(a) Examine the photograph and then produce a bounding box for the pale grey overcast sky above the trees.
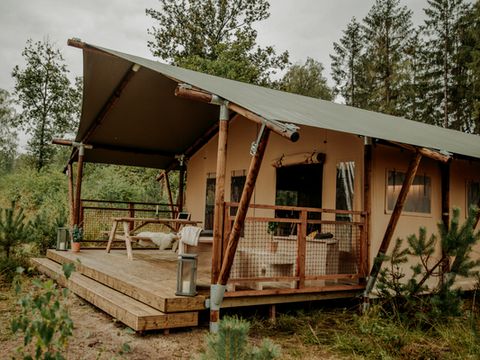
[0,0,432,91]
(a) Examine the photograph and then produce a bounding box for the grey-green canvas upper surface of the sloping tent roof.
[74,40,480,158]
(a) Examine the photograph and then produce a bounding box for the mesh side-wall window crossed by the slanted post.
[387,170,432,214]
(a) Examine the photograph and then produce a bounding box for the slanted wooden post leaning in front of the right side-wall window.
[364,152,422,301]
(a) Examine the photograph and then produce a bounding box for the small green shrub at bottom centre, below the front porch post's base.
[202,317,280,360]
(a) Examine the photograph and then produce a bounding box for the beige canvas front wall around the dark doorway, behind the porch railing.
[186,118,363,221]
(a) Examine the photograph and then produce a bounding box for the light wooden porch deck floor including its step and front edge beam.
[32,249,362,331]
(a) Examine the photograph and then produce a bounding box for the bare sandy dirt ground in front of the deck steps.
[0,281,336,360]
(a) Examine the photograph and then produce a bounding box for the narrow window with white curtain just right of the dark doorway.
[335,161,355,221]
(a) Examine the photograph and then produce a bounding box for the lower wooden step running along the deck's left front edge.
[31,258,198,331]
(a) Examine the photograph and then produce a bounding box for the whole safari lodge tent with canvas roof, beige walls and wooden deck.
[31,39,480,331]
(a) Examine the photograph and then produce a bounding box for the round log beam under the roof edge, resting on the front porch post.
[175,85,300,142]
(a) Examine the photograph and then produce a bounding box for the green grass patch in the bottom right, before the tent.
[252,308,480,359]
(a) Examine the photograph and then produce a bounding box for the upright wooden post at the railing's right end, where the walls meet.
[359,138,373,283]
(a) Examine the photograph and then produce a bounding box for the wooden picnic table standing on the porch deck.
[107,217,201,260]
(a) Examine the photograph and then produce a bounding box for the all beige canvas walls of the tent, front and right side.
[186,118,480,290]
